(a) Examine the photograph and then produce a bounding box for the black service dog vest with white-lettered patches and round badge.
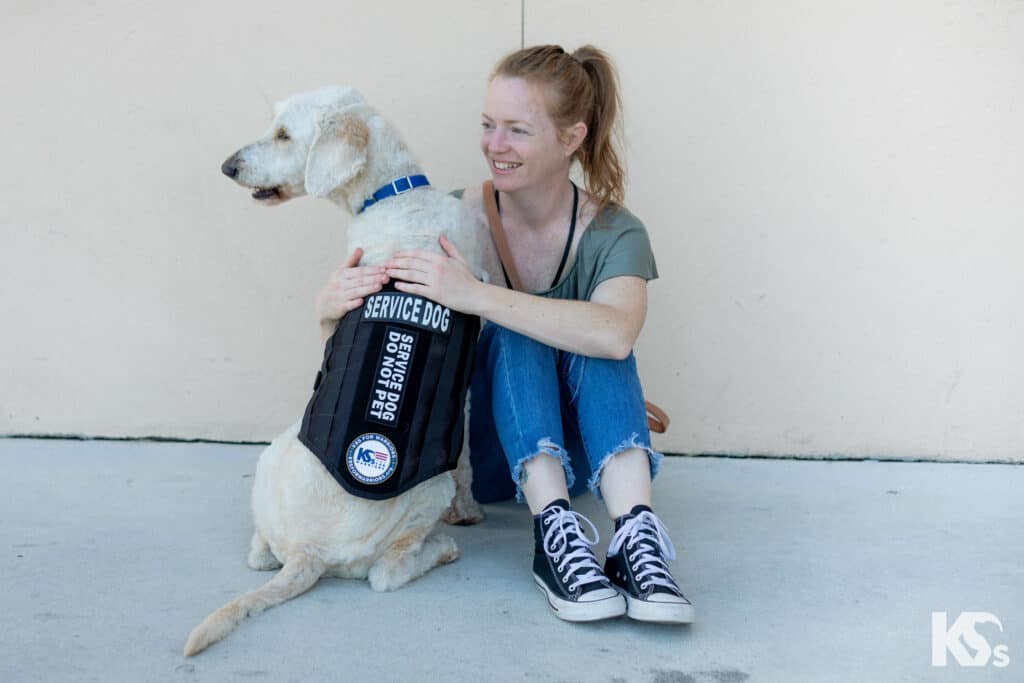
[299,283,480,500]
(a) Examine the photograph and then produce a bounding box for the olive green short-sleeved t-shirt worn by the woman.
[452,189,657,301]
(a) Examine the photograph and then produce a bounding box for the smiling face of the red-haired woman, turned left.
[480,76,578,193]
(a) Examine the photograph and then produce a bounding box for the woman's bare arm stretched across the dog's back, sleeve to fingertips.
[385,237,647,359]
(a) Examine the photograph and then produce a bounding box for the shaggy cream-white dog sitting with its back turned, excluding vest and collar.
[184,87,486,655]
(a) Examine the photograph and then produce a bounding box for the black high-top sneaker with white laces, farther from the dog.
[604,505,693,624]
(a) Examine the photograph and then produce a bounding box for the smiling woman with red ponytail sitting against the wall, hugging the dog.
[317,45,693,623]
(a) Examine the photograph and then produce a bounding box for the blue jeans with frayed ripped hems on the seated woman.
[469,323,662,503]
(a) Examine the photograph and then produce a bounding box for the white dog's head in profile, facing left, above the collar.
[220,86,372,205]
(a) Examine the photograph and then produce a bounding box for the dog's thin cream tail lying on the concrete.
[185,552,326,656]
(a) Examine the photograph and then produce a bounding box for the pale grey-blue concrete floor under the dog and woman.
[0,439,1024,683]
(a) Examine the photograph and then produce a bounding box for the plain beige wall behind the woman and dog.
[0,0,1024,460]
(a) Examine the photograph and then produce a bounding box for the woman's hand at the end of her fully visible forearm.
[384,234,482,313]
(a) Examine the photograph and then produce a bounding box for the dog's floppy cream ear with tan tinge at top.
[306,109,370,198]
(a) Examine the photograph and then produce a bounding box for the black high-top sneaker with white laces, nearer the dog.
[534,499,626,622]
